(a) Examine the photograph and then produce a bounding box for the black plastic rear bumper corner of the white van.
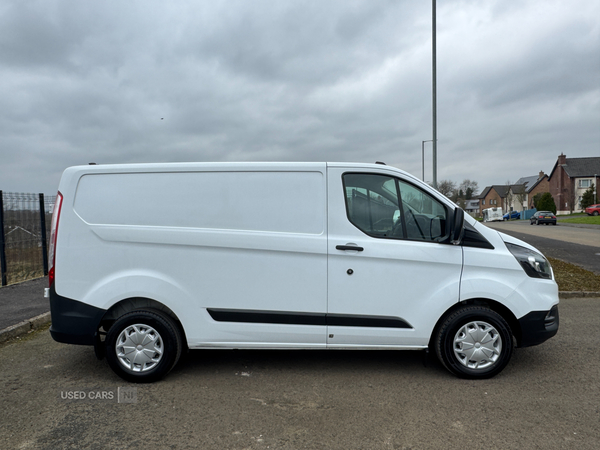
[50,285,106,345]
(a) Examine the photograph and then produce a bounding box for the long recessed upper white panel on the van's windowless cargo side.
[74,172,325,235]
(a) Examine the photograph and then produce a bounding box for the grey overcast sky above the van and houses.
[0,0,600,194]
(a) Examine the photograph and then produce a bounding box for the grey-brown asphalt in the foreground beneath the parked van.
[0,298,600,450]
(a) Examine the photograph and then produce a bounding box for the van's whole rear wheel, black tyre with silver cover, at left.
[105,310,182,383]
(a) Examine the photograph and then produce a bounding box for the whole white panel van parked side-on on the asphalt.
[49,163,558,382]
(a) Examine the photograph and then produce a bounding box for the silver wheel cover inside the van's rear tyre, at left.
[115,323,164,373]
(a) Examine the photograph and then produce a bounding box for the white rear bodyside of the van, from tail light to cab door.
[56,164,327,348]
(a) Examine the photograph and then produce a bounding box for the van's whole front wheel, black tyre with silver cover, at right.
[435,306,513,379]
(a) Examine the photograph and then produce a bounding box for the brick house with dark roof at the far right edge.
[548,153,600,214]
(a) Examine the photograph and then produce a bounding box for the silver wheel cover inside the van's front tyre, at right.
[453,321,502,370]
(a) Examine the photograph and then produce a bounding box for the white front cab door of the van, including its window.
[327,166,462,348]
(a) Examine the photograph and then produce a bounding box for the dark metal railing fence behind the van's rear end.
[0,191,56,286]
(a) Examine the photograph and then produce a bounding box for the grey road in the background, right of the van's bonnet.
[485,220,600,275]
